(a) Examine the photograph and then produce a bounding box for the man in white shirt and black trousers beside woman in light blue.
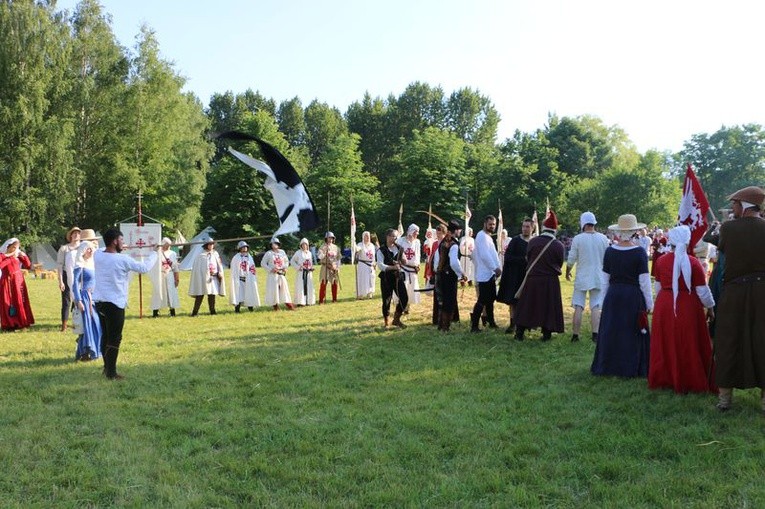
[93,228,157,380]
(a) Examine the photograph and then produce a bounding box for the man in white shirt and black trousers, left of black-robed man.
[470,216,502,332]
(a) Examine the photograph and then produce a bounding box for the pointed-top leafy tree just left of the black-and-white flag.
[111,27,212,231]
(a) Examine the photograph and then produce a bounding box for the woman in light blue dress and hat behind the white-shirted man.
[72,238,101,361]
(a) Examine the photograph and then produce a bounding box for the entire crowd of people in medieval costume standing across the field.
[5,186,765,412]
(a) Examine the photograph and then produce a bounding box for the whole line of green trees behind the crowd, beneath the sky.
[0,0,765,251]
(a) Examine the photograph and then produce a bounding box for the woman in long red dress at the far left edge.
[0,238,35,330]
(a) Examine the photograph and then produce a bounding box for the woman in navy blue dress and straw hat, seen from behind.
[590,214,653,377]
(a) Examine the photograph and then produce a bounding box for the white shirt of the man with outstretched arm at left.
[93,249,157,309]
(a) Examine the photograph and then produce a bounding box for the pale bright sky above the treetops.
[57,0,765,152]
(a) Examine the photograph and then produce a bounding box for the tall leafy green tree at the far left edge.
[0,0,74,242]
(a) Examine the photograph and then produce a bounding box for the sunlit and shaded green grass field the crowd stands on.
[0,267,765,508]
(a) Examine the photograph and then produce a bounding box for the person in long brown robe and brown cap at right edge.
[715,186,765,413]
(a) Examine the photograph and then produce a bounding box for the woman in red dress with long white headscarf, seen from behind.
[648,225,717,394]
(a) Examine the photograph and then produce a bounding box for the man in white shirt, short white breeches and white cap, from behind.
[566,212,608,341]
